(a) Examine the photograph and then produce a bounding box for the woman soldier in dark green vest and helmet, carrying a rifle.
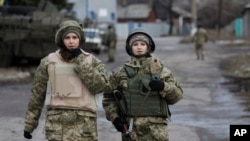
[103,28,183,141]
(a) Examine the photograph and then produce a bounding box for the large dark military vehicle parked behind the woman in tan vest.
[0,0,74,67]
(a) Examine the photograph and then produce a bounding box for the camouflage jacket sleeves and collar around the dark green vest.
[102,57,183,121]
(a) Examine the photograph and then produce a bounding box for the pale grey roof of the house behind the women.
[117,4,151,19]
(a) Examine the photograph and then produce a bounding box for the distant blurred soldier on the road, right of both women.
[192,25,208,60]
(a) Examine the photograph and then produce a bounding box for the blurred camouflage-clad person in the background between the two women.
[106,26,117,62]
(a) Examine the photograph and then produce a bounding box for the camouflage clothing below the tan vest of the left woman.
[44,109,98,141]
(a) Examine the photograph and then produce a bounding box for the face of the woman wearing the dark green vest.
[132,41,148,56]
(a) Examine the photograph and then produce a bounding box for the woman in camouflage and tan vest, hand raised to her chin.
[24,20,109,141]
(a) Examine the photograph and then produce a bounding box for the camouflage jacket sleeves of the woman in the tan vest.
[24,50,109,132]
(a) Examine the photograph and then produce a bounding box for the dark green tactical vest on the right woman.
[120,62,170,118]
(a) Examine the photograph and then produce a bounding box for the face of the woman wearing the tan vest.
[63,33,80,50]
